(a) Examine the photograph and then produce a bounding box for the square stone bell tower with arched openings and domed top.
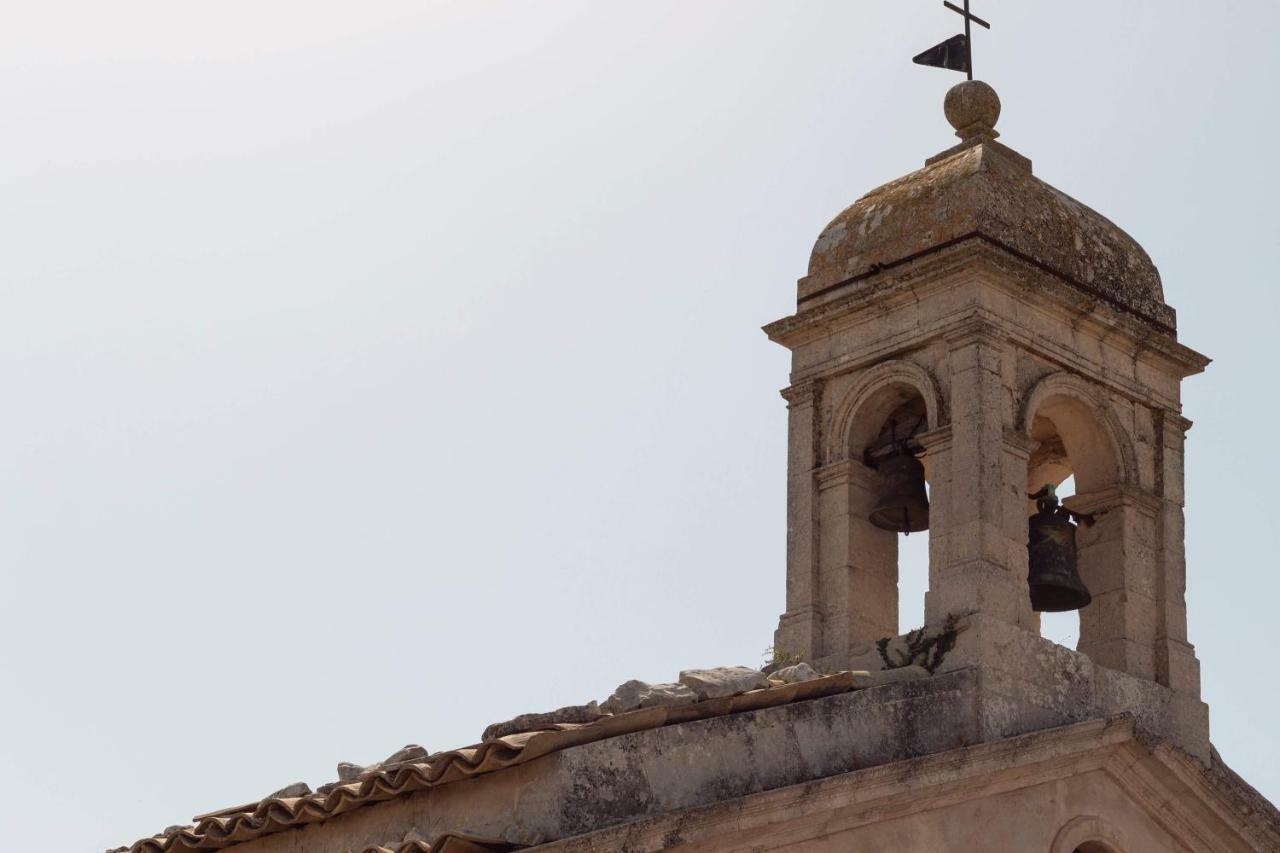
[765,81,1208,758]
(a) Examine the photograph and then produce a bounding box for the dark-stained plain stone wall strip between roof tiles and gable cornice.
[217,672,979,853]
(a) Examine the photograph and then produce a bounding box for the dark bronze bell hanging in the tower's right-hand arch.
[1027,487,1093,613]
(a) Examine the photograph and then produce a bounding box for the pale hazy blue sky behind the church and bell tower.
[0,0,1280,853]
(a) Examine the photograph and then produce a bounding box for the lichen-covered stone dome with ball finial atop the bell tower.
[800,82,1174,328]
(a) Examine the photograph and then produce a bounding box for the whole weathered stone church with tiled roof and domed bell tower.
[112,81,1280,853]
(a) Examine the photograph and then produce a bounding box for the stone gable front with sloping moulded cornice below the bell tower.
[529,720,1280,853]
